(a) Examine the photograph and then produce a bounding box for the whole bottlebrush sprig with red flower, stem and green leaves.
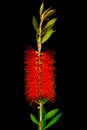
[25,2,62,130]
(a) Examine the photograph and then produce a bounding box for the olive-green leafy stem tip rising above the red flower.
[32,2,57,53]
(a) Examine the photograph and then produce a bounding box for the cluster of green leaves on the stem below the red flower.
[30,99,62,130]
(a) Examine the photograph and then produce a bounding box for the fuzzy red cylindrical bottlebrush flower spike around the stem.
[25,47,55,103]
